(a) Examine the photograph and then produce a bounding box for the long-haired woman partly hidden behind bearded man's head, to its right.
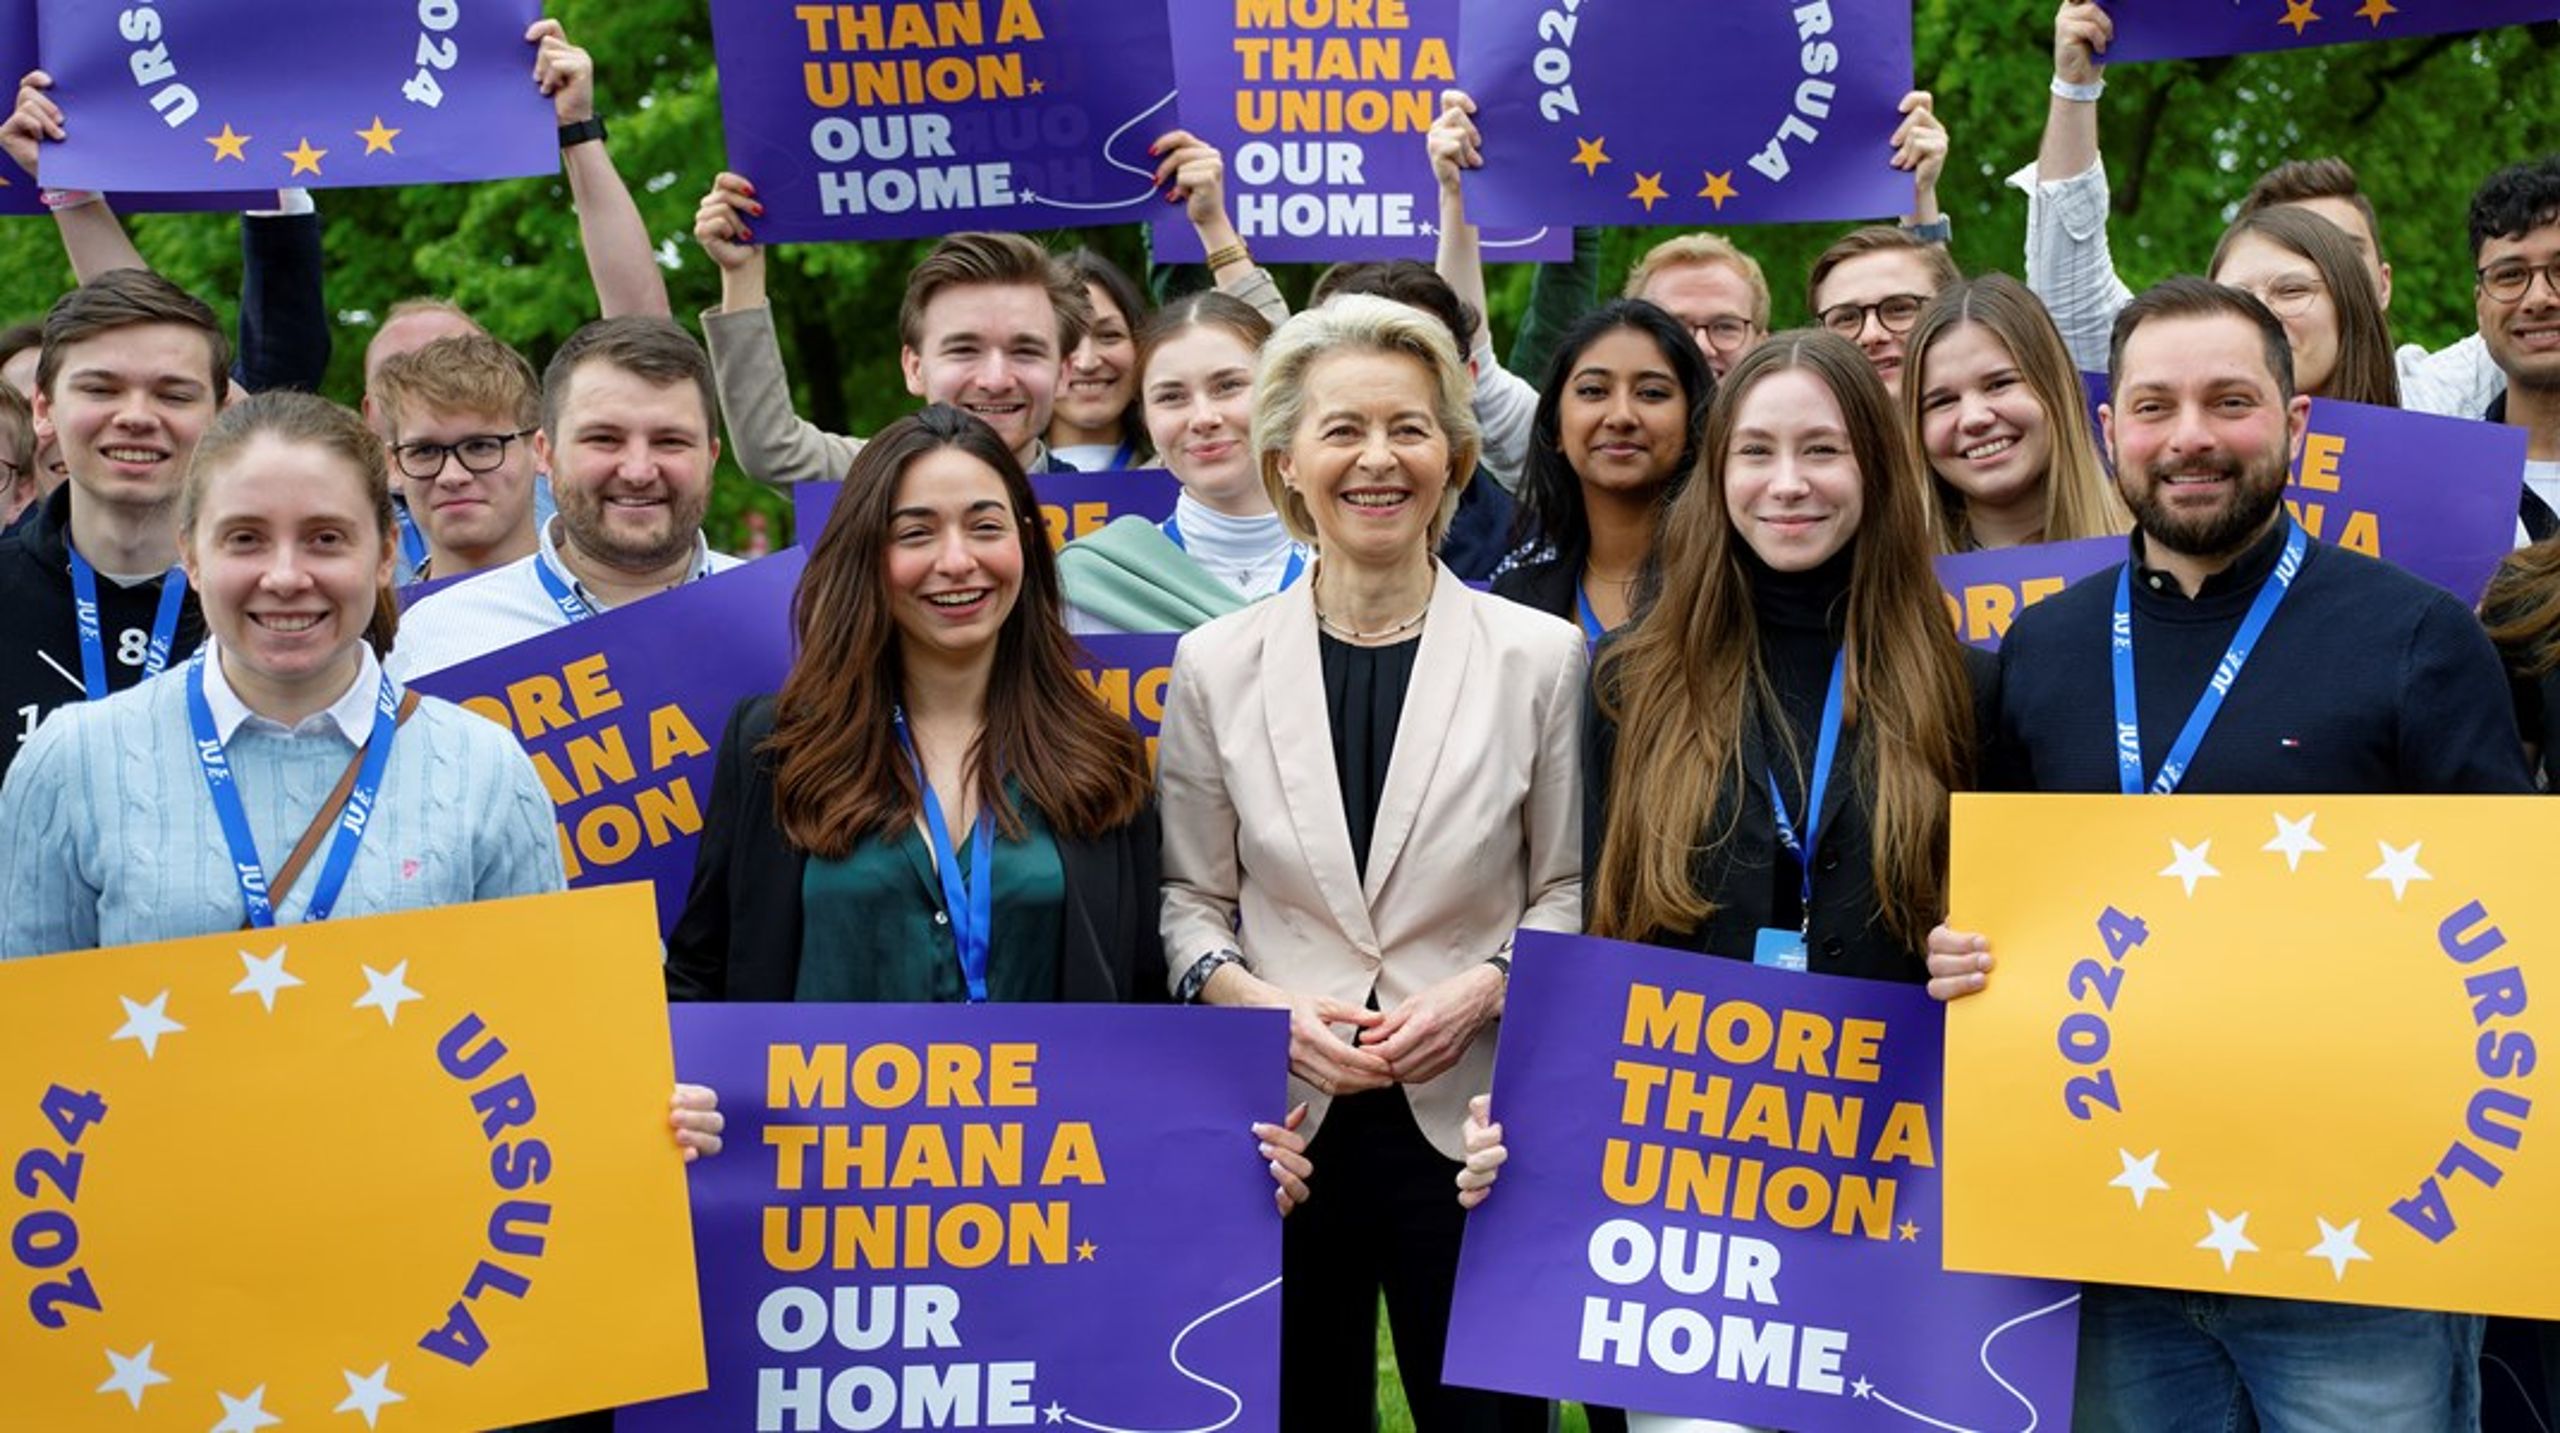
[2207,205,2399,407]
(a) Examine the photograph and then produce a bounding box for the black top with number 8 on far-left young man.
[0,484,205,775]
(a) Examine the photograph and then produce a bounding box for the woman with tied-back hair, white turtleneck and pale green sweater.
[1057,292,1313,632]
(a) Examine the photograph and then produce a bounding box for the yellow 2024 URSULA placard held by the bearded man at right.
[1946,796,2560,1318]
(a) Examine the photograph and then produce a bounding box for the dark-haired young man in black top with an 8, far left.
[0,269,230,773]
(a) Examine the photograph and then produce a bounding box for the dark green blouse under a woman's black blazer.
[794,783,1068,1006]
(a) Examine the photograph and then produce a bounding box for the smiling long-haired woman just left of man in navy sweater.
[1902,274,2130,553]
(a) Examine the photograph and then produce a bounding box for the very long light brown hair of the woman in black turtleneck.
[1587,330,1974,947]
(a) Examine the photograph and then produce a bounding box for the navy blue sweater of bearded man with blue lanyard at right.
[1989,525,2532,796]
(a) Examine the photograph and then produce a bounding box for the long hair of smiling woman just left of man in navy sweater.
[1902,274,2132,553]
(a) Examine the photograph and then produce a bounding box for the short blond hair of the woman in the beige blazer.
[1254,294,1482,548]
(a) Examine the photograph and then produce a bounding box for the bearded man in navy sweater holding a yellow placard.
[1928,279,2532,1433]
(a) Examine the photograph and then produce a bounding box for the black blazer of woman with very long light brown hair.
[1582,647,1999,983]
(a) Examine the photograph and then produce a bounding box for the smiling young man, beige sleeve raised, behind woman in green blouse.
[694,223,1093,484]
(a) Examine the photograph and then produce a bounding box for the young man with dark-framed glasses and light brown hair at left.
[369,333,543,581]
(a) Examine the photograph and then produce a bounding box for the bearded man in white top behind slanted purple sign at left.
[384,317,737,681]
